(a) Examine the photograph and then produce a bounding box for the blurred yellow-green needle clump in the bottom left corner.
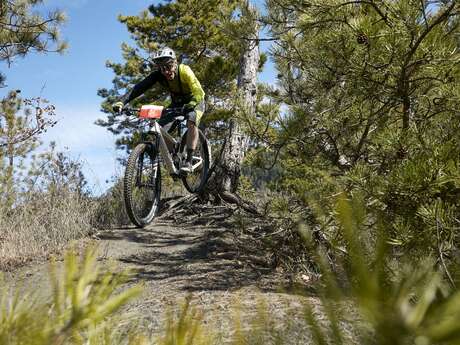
[0,248,141,345]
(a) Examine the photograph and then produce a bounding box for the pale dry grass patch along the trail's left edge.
[0,188,95,270]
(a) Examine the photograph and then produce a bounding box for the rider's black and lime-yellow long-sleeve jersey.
[122,64,204,107]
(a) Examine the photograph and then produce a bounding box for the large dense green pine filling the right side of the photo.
[258,0,460,255]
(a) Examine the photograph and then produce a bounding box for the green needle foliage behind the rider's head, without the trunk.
[97,0,241,151]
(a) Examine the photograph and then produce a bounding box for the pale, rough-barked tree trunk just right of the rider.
[208,3,260,201]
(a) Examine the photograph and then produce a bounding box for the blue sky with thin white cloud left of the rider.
[0,0,274,194]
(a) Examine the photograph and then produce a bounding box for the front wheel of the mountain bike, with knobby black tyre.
[123,144,161,227]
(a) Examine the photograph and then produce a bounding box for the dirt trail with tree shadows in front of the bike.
[7,208,318,344]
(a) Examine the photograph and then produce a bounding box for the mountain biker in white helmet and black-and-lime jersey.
[112,47,204,173]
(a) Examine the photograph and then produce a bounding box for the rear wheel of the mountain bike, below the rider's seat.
[180,129,210,193]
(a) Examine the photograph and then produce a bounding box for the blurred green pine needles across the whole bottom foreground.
[6,193,460,345]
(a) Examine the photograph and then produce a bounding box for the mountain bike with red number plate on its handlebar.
[123,105,210,227]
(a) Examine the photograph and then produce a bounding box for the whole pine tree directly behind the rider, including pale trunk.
[97,0,260,202]
